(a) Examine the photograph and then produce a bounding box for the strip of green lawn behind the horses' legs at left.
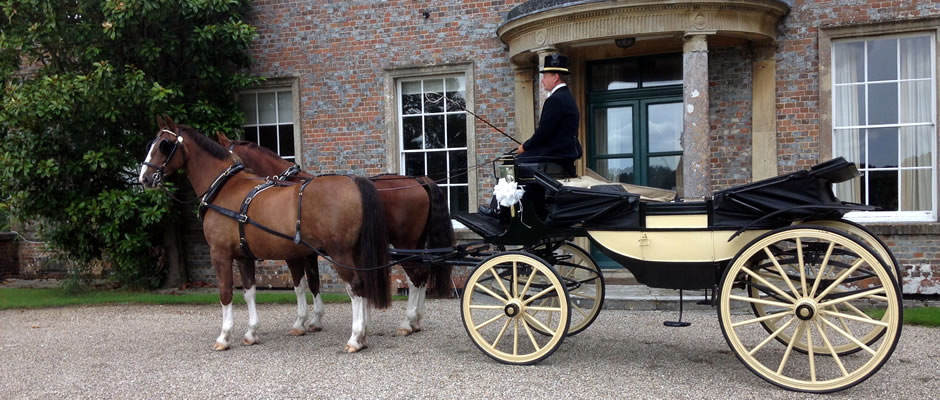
[0,288,405,310]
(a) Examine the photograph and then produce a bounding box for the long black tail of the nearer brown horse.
[353,176,392,308]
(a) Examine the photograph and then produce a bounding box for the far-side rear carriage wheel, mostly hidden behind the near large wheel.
[748,220,901,356]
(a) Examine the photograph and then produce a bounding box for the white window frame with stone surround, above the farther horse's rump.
[385,63,478,216]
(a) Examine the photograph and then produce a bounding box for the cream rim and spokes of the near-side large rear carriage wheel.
[719,227,901,392]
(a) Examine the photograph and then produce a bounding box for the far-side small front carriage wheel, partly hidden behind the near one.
[533,242,605,336]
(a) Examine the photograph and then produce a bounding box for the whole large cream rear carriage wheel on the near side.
[718,225,902,393]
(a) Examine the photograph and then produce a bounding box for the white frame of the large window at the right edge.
[820,30,940,223]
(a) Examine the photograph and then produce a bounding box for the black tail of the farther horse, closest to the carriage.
[416,176,457,297]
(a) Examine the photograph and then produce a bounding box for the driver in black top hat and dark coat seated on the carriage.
[478,54,582,217]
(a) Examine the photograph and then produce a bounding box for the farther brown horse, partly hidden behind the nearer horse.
[217,133,455,335]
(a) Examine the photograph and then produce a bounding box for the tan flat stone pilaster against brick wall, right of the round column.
[751,45,777,181]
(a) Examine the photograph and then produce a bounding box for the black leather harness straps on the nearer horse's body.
[199,162,316,260]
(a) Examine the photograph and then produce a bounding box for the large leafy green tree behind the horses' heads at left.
[0,0,256,287]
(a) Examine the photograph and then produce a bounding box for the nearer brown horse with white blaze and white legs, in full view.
[139,117,391,352]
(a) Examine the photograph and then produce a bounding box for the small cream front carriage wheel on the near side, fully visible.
[460,252,570,364]
